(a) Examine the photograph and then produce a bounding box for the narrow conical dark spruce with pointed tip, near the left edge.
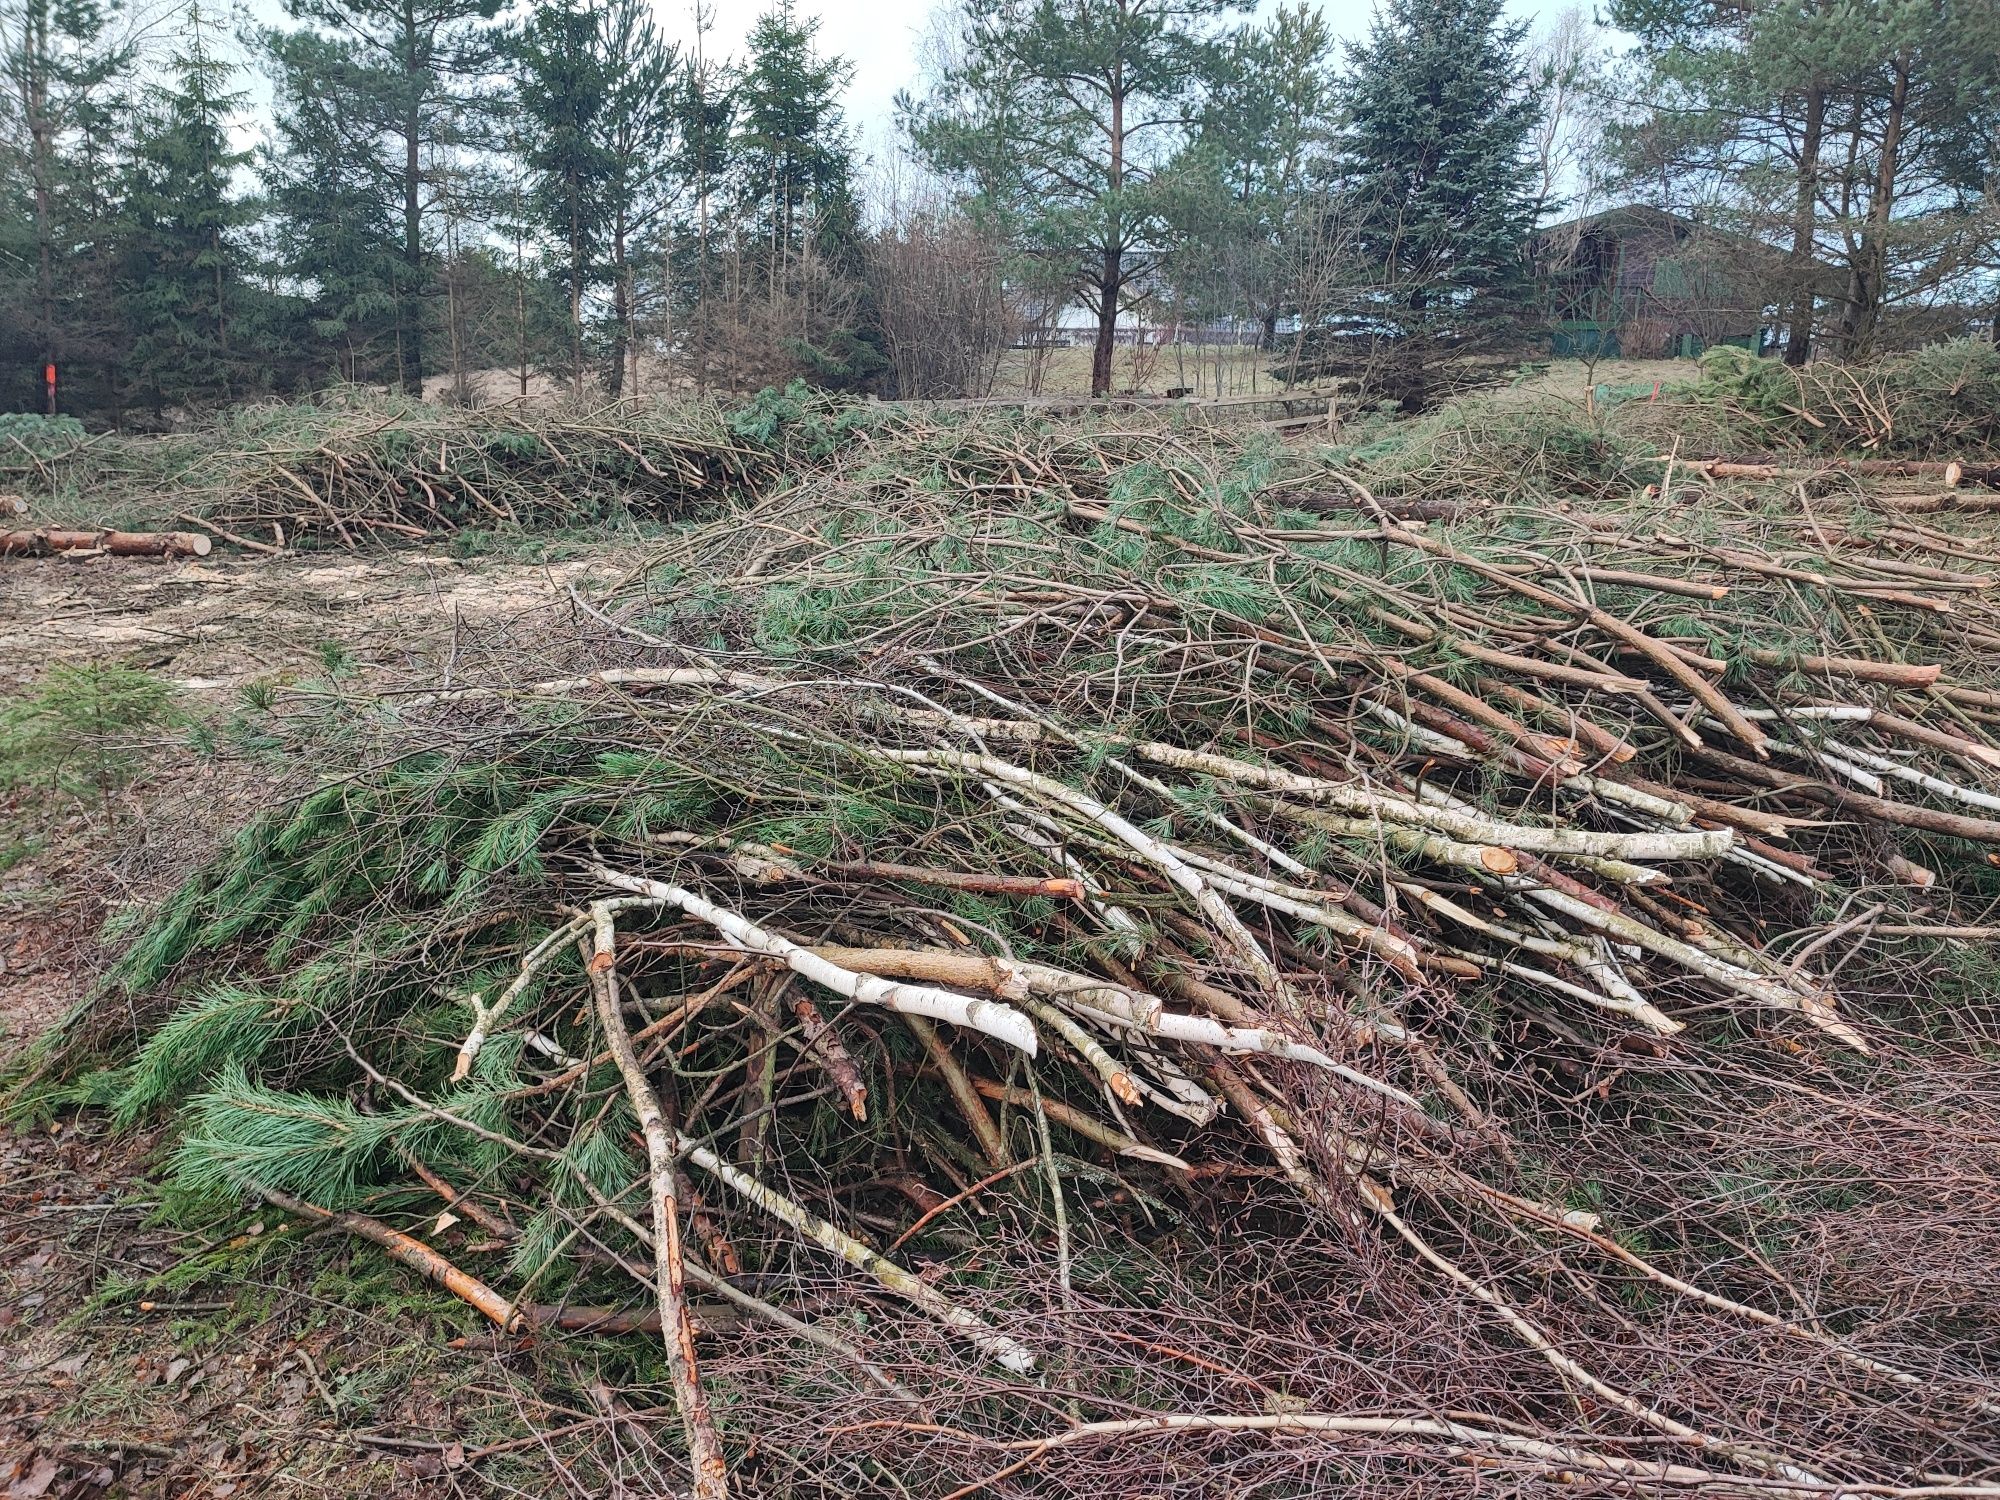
[118,6,256,410]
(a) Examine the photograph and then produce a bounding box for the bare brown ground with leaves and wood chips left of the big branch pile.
[0,550,632,1500]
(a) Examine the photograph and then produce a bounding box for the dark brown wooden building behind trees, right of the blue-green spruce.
[1528,204,1824,360]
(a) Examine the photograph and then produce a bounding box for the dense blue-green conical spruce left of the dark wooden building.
[1308,0,1540,412]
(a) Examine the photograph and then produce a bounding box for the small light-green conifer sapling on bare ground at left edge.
[0,662,174,816]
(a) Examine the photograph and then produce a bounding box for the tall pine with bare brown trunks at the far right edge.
[1610,0,2000,364]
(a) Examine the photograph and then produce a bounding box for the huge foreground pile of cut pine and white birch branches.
[23,406,2000,1496]
